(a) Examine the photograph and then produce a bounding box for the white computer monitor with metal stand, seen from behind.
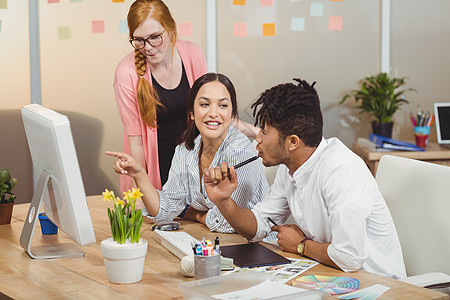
[20,104,95,259]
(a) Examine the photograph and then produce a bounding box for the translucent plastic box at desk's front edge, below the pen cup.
[178,271,329,300]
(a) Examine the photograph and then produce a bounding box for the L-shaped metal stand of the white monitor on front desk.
[20,171,84,259]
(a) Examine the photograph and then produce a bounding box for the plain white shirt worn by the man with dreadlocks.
[252,138,406,278]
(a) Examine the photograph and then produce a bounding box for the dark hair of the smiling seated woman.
[178,73,238,150]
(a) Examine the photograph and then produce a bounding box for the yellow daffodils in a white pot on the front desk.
[100,188,148,283]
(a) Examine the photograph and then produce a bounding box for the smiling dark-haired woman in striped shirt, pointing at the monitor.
[106,73,268,233]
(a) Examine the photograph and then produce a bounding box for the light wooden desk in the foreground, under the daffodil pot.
[0,196,449,299]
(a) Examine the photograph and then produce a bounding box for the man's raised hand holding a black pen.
[203,162,238,205]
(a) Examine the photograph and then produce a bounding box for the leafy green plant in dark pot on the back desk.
[339,73,414,138]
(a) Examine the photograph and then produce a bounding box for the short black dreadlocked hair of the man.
[251,78,323,147]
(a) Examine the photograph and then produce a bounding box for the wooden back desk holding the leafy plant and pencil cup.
[352,142,450,176]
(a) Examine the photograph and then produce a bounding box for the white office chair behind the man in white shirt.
[376,155,450,294]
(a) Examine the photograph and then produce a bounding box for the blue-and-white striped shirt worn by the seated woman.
[142,126,269,233]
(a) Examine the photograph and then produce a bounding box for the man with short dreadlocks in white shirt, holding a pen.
[204,79,406,278]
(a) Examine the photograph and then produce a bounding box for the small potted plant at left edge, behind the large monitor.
[0,169,17,225]
